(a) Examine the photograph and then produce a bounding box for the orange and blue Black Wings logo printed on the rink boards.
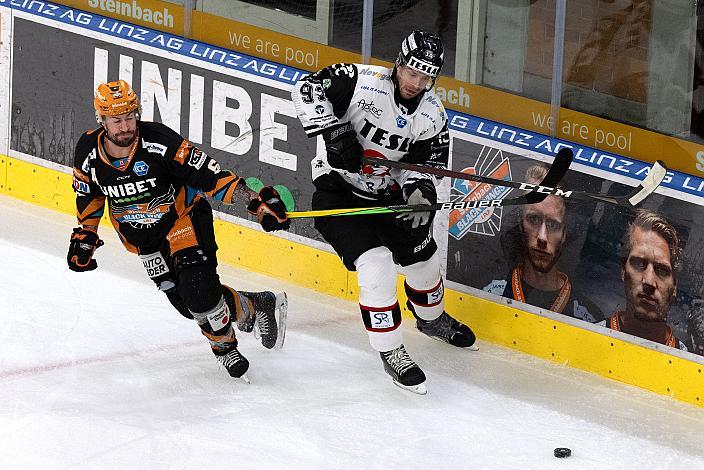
[449,146,512,240]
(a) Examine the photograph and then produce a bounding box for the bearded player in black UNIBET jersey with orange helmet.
[67,80,289,380]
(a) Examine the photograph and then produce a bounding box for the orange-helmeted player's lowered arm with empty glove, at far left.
[66,134,105,272]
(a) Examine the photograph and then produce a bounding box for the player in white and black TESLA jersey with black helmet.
[292,31,475,394]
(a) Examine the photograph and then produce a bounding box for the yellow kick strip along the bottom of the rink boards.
[5,155,704,406]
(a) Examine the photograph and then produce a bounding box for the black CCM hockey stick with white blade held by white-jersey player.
[363,148,667,207]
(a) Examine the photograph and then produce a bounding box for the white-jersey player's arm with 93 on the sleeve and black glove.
[291,64,364,173]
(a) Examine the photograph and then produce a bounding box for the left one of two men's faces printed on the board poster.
[521,196,565,273]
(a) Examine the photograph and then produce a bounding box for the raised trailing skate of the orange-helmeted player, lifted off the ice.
[223,286,288,350]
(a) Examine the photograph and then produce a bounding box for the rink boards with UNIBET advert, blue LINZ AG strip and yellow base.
[0,1,704,405]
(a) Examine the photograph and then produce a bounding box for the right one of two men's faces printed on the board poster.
[621,227,676,321]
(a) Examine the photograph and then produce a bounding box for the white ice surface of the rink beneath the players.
[0,196,704,470]
